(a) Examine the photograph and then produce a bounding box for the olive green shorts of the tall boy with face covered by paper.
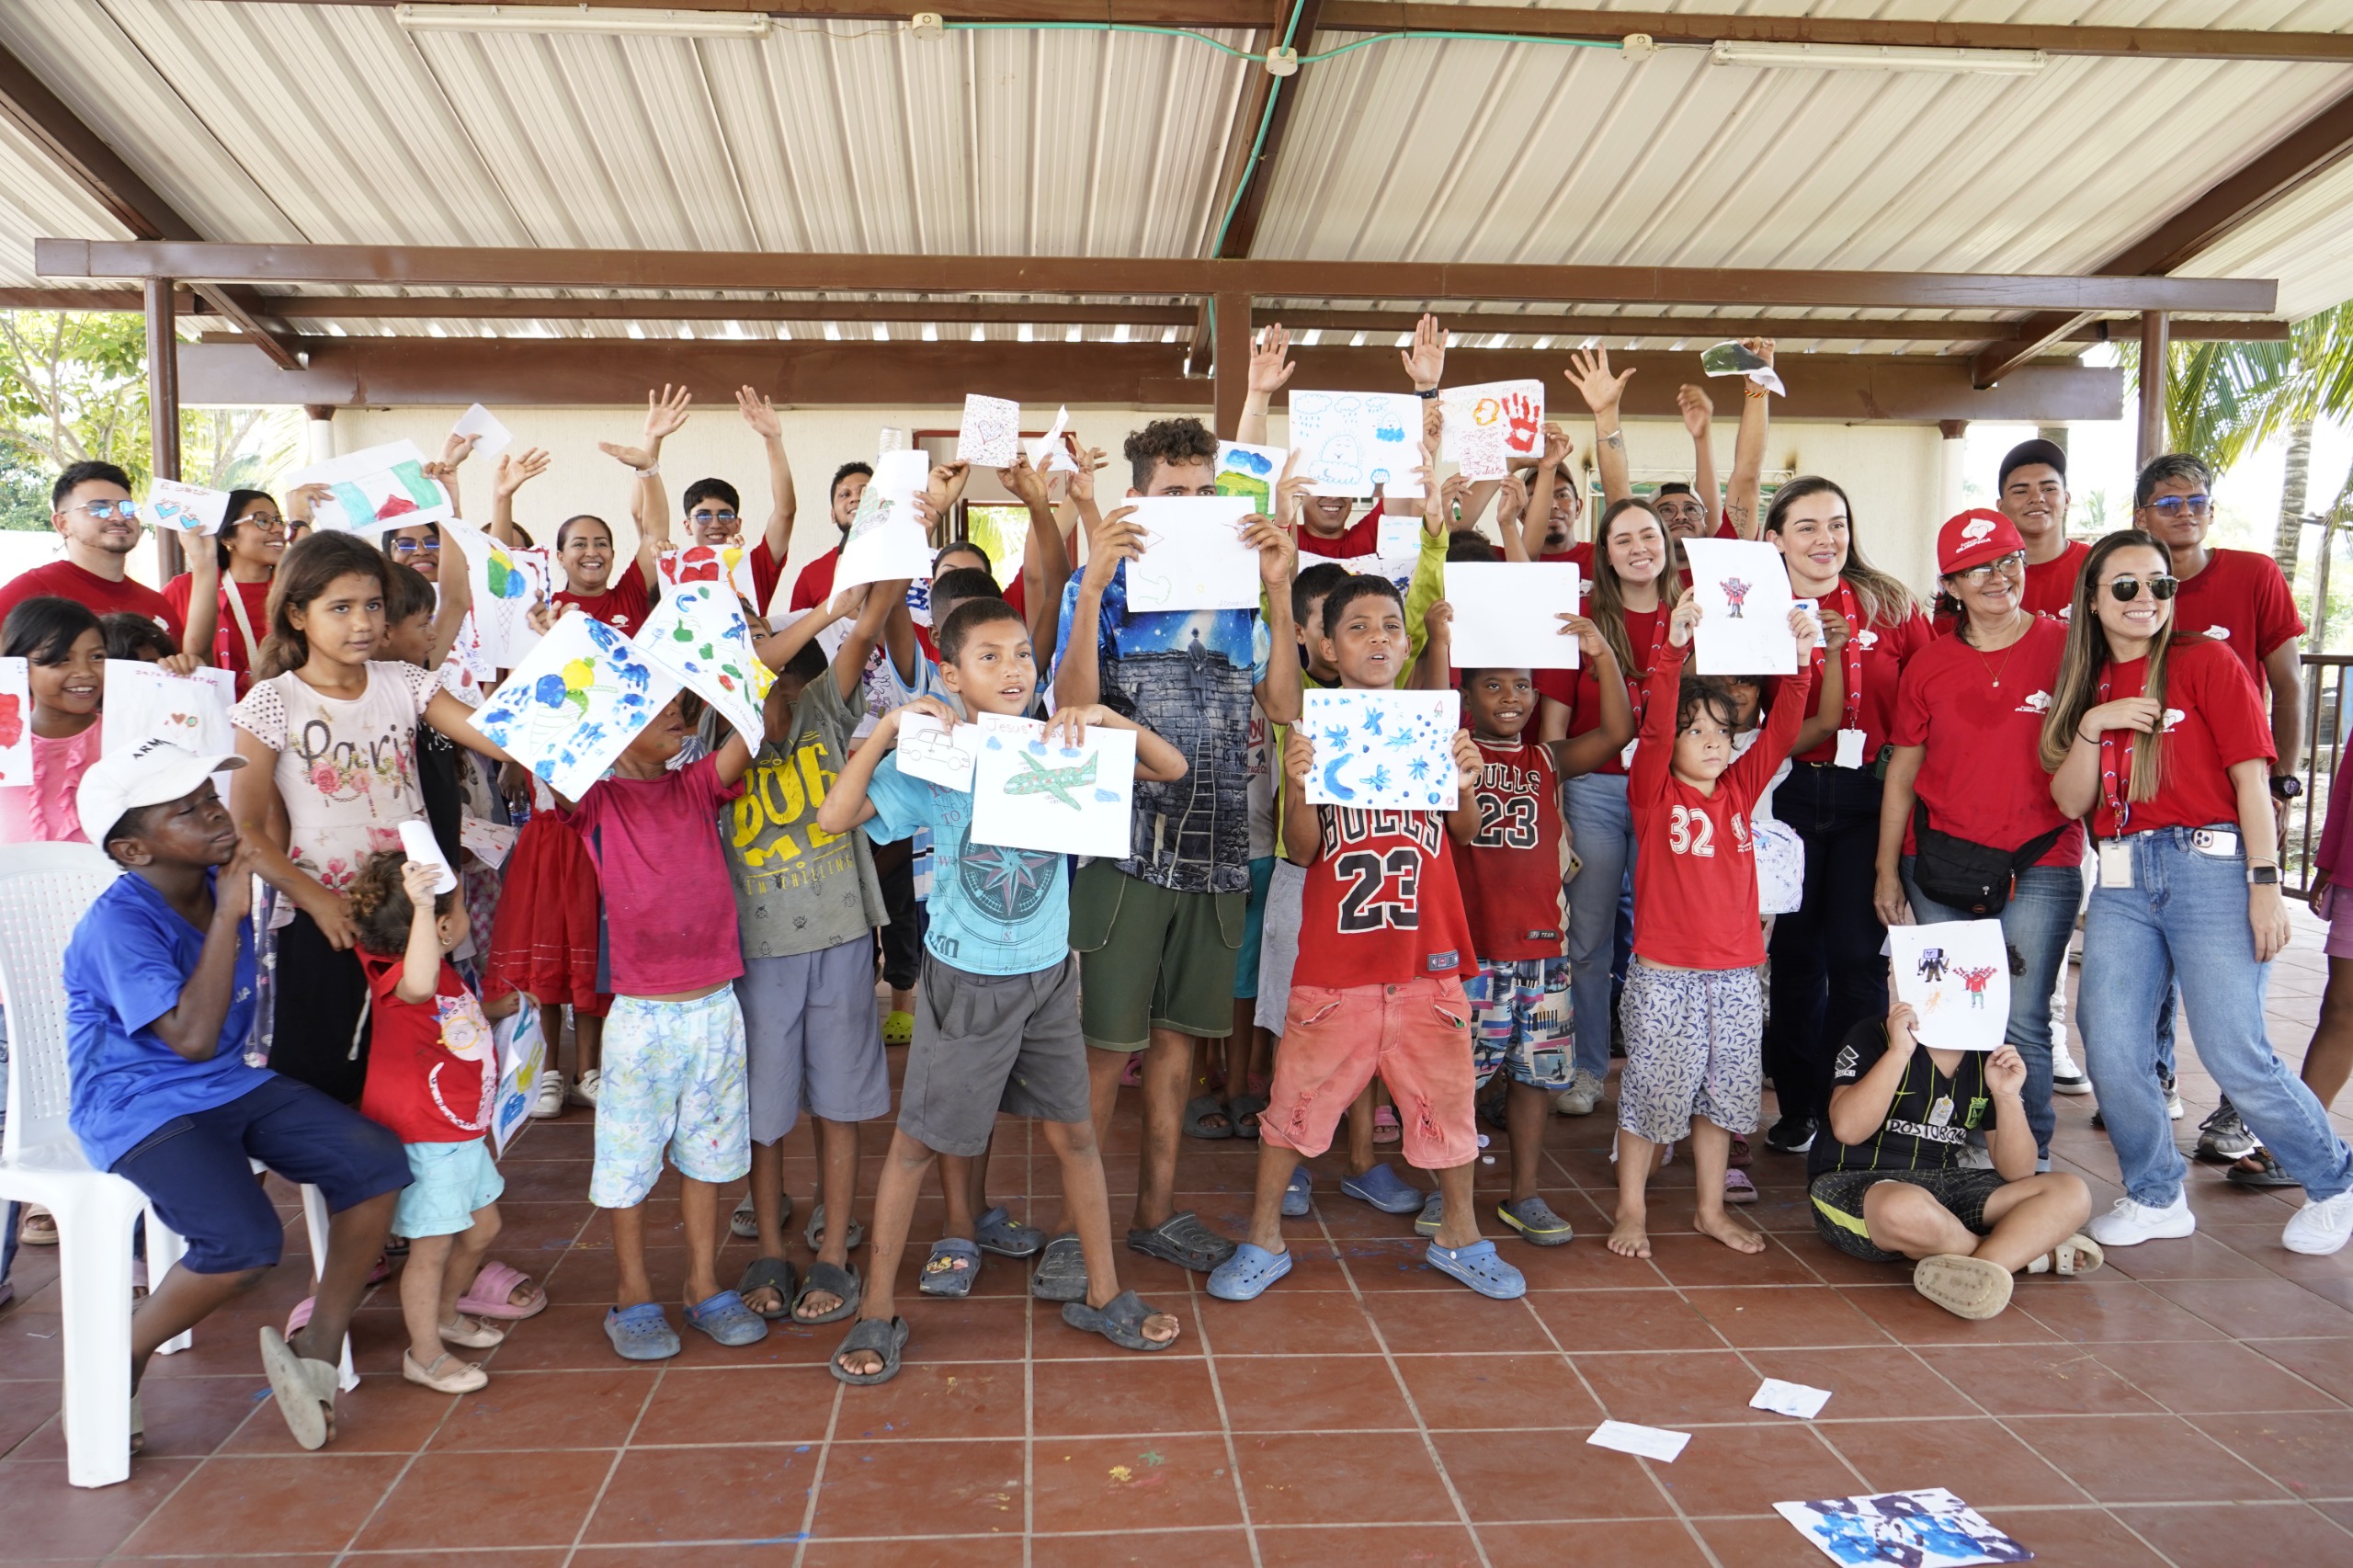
[1071,859,1249,1050]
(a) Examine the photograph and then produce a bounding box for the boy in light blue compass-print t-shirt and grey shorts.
[816,598,1186,1384]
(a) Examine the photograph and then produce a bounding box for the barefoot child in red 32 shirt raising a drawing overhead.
[1609,598,1814,1257]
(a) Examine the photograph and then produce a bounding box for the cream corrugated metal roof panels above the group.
[0,0,2353,353]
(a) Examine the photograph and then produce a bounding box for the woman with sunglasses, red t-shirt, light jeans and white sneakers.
[2042,529,2353,1255]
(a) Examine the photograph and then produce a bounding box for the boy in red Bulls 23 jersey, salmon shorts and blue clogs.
[1210,577,1527,1302]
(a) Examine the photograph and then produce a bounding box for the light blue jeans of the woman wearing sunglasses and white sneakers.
[2077,829,2353,1208]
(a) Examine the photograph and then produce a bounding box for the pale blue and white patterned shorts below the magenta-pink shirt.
[588,986,751,1208]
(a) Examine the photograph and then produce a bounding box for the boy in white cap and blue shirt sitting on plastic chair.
[63,739,409,1452]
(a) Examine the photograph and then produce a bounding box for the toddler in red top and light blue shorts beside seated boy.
[350,850,506,1393]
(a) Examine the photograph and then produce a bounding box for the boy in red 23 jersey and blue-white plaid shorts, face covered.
[1415,617,1633,1248]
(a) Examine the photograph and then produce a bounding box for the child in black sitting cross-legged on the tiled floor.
[1807,984,2106,1318]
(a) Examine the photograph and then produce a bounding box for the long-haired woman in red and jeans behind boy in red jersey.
[1537,499,1682,1116]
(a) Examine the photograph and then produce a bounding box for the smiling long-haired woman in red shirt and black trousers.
[1762,475,1929,1153]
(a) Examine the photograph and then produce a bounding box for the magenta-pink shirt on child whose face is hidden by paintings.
[564,756,744,996]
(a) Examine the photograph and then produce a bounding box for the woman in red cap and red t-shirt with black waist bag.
[1873,508,2085,1156]
